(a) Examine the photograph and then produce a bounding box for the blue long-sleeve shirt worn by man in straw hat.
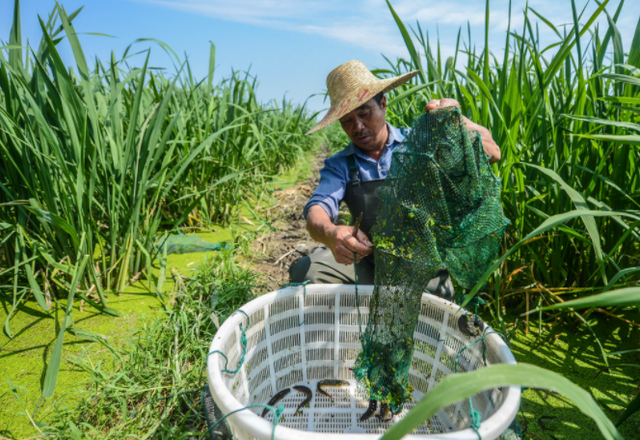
[303,123,404,222]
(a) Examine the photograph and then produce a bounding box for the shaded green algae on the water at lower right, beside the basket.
[504,312,640,440]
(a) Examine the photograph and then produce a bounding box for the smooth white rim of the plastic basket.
[207,284,521,440]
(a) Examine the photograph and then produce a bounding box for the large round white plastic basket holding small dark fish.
[207,284,520,440]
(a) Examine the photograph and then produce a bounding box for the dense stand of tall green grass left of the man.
[0,0,314,397]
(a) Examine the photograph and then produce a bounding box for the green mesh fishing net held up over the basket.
[353,107,509,412]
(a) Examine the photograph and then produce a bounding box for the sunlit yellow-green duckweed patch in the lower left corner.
[0,287,160,438]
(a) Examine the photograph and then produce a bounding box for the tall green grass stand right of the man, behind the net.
[376,0,640,300]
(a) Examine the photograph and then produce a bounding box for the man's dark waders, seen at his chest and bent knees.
[289,146,454,301]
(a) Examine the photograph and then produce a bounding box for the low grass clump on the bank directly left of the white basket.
[40,251,255,439]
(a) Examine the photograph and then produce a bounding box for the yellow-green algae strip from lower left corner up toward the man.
[0,153,315,438]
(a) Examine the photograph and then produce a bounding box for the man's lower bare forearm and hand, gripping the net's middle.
[307,205,373,264]
